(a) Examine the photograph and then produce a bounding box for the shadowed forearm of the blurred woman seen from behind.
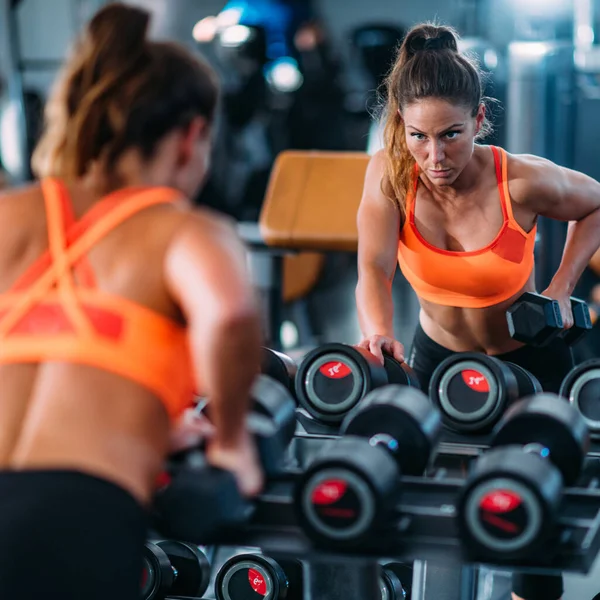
[199,315,261,448]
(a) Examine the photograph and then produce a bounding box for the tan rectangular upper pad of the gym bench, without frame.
[259,151,370,252]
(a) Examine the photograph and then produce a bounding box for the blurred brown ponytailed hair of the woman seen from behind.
[32,3,218,180]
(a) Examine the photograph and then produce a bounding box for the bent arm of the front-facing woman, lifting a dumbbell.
[509,156,600,295]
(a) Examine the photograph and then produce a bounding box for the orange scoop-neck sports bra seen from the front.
[398,146,536,308]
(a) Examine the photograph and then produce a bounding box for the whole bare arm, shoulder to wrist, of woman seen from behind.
[165,215,260,448]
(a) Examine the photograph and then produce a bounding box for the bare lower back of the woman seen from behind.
[0,363,169,504]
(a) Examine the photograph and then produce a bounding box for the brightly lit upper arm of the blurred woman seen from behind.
[165,214,257,331]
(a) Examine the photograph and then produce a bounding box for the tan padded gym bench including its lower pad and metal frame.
[239,150,370,347]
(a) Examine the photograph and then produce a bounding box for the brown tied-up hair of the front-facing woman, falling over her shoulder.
[382,24,491,220]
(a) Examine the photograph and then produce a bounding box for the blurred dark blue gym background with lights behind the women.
[0,0,600,600]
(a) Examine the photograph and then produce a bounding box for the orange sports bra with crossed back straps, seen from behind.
[0,179,195,418]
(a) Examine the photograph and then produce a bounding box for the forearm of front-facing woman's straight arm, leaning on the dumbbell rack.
[356,271,394,338]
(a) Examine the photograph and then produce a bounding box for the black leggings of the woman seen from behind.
[0,470,147,600]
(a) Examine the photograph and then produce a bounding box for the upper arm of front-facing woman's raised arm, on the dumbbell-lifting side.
[509,155,600,221]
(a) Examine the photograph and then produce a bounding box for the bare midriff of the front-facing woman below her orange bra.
[419,272,535,355]
